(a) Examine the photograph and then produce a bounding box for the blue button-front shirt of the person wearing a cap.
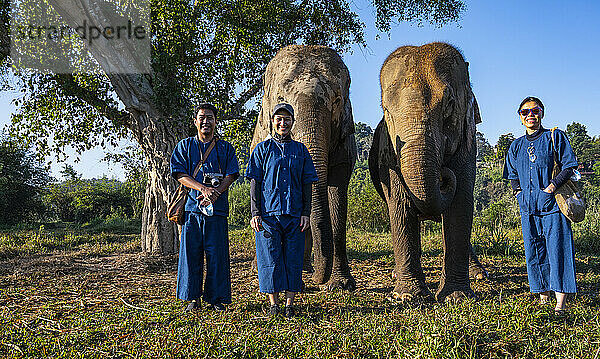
[246,138,318,217]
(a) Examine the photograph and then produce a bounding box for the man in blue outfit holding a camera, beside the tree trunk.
[171,104,239,311]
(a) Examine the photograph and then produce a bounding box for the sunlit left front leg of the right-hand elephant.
[386,170,433,301]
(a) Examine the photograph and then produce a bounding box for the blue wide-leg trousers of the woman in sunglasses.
[521,212,577,293]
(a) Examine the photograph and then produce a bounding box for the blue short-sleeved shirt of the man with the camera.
[171,136,240,217]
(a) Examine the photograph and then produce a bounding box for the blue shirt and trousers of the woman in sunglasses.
[506,129,577,293]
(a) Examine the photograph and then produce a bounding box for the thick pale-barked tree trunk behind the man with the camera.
[50,0,188,254]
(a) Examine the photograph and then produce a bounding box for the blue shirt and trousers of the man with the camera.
[171,137,239,304]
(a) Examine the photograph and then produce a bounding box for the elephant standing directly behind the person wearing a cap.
[251,45,357,290]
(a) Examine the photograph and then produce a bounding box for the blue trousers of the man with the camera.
[177,212,231,304]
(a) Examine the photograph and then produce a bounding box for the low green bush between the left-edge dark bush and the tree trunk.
[44,174,139,223]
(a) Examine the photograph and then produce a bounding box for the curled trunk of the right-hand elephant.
[400,136,456,217]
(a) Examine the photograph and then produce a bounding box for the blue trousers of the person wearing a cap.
[255,215,304,293]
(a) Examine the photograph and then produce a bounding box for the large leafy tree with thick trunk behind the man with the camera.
[0,0,464,253]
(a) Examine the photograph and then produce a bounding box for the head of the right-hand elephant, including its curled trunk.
[380,43,481,218]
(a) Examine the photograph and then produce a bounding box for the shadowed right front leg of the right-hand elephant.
[436,170,476,302]
